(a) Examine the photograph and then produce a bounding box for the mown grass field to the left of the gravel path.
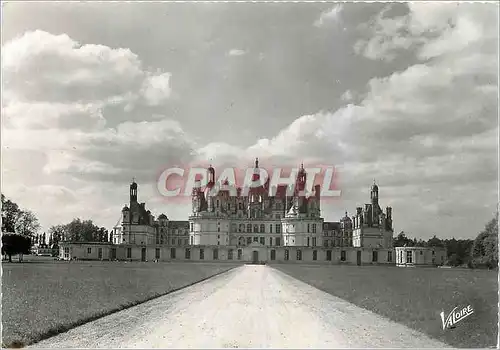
[2,257,241,347]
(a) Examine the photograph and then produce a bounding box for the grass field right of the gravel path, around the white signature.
[272,265,498,348]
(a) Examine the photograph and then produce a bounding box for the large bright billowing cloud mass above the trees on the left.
[2,30,185,228]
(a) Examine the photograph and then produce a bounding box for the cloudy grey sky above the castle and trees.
[1,2,499,239]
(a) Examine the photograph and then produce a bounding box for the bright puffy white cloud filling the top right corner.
[355,2,498,61]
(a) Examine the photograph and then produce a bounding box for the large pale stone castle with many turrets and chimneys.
[60,159,406,265]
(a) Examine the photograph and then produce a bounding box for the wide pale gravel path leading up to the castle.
[32,265,449,348]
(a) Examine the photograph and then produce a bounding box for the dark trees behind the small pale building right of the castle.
[394,212,498,269]
